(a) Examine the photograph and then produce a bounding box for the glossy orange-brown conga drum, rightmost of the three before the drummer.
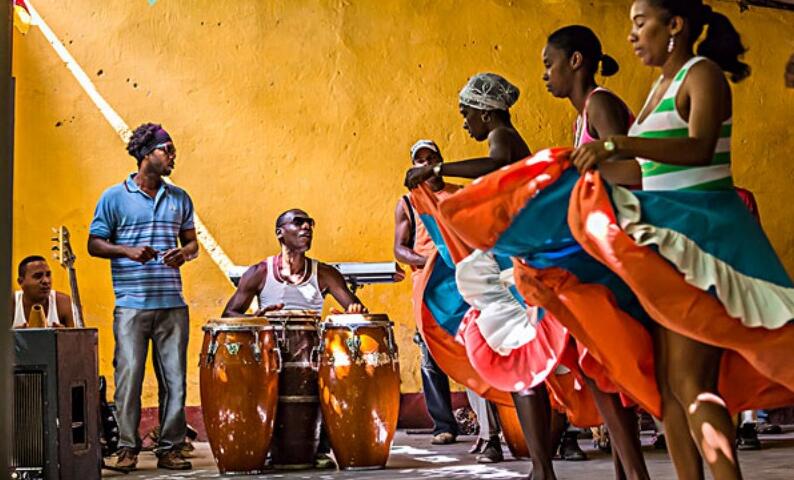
[318,314,400,470]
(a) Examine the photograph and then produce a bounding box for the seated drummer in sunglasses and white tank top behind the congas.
[218,209,367,317]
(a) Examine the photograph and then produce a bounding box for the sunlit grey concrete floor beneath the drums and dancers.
[102,429,794,480]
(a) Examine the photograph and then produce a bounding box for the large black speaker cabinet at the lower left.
[10,328,102,480]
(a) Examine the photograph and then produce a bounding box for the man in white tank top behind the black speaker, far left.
[13,255,74,328]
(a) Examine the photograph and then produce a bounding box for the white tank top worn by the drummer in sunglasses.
[259,257,323,310]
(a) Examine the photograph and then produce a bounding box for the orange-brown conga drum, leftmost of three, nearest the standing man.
[199,318,281,474]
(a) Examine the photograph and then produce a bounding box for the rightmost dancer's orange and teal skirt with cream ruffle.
[568,169,794,412]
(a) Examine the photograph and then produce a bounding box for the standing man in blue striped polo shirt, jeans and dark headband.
[88,123,198,472]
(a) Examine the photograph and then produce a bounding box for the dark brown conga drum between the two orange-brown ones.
[265,310,321,469]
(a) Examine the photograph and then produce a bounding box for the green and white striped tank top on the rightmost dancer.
[629,57,733,190]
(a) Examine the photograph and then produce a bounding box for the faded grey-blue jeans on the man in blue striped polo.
[113,307,189,455]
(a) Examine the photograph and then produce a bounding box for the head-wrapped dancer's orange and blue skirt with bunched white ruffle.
[412,182,601,426]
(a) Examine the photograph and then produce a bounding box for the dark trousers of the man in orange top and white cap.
[417,340,458,435]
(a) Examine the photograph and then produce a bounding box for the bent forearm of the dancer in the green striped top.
[611,135,715,166]
